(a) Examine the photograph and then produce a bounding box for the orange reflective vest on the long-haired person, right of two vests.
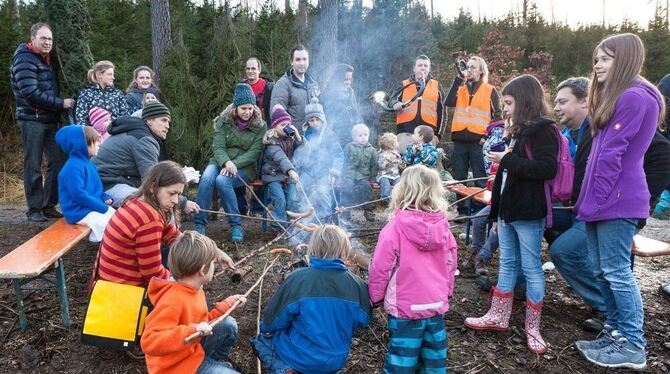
[451,83,493,135]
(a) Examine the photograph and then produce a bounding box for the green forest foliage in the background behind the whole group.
[0,0,670,168]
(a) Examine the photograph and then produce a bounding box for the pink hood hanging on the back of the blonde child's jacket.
[394,210,451,251]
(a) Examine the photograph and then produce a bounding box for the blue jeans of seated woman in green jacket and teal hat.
[193,165,249,227]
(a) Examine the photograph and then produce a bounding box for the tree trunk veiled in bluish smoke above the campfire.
[312,0,338,83]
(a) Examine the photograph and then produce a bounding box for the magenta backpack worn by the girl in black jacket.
[524,123,575,228]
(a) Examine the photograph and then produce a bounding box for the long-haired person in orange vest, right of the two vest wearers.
[445,56,502,196]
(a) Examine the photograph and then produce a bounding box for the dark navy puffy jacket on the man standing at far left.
[10,43,63,124]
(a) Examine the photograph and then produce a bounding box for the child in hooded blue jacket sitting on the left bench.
[56,125,115,242]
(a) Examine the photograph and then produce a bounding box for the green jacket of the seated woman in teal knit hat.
[209,105,267,180]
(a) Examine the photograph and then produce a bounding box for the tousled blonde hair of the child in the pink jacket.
[390,164,447,216]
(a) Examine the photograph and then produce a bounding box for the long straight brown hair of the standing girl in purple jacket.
[589,34,665,135]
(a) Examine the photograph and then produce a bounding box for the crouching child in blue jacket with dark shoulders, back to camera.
[251,225,370,374]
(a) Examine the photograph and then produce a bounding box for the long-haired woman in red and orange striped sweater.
[97,161,233,287]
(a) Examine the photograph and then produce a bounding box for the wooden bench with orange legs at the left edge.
[0,218,91,331]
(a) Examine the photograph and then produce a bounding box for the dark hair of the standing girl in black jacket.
[502,74,549,138]
